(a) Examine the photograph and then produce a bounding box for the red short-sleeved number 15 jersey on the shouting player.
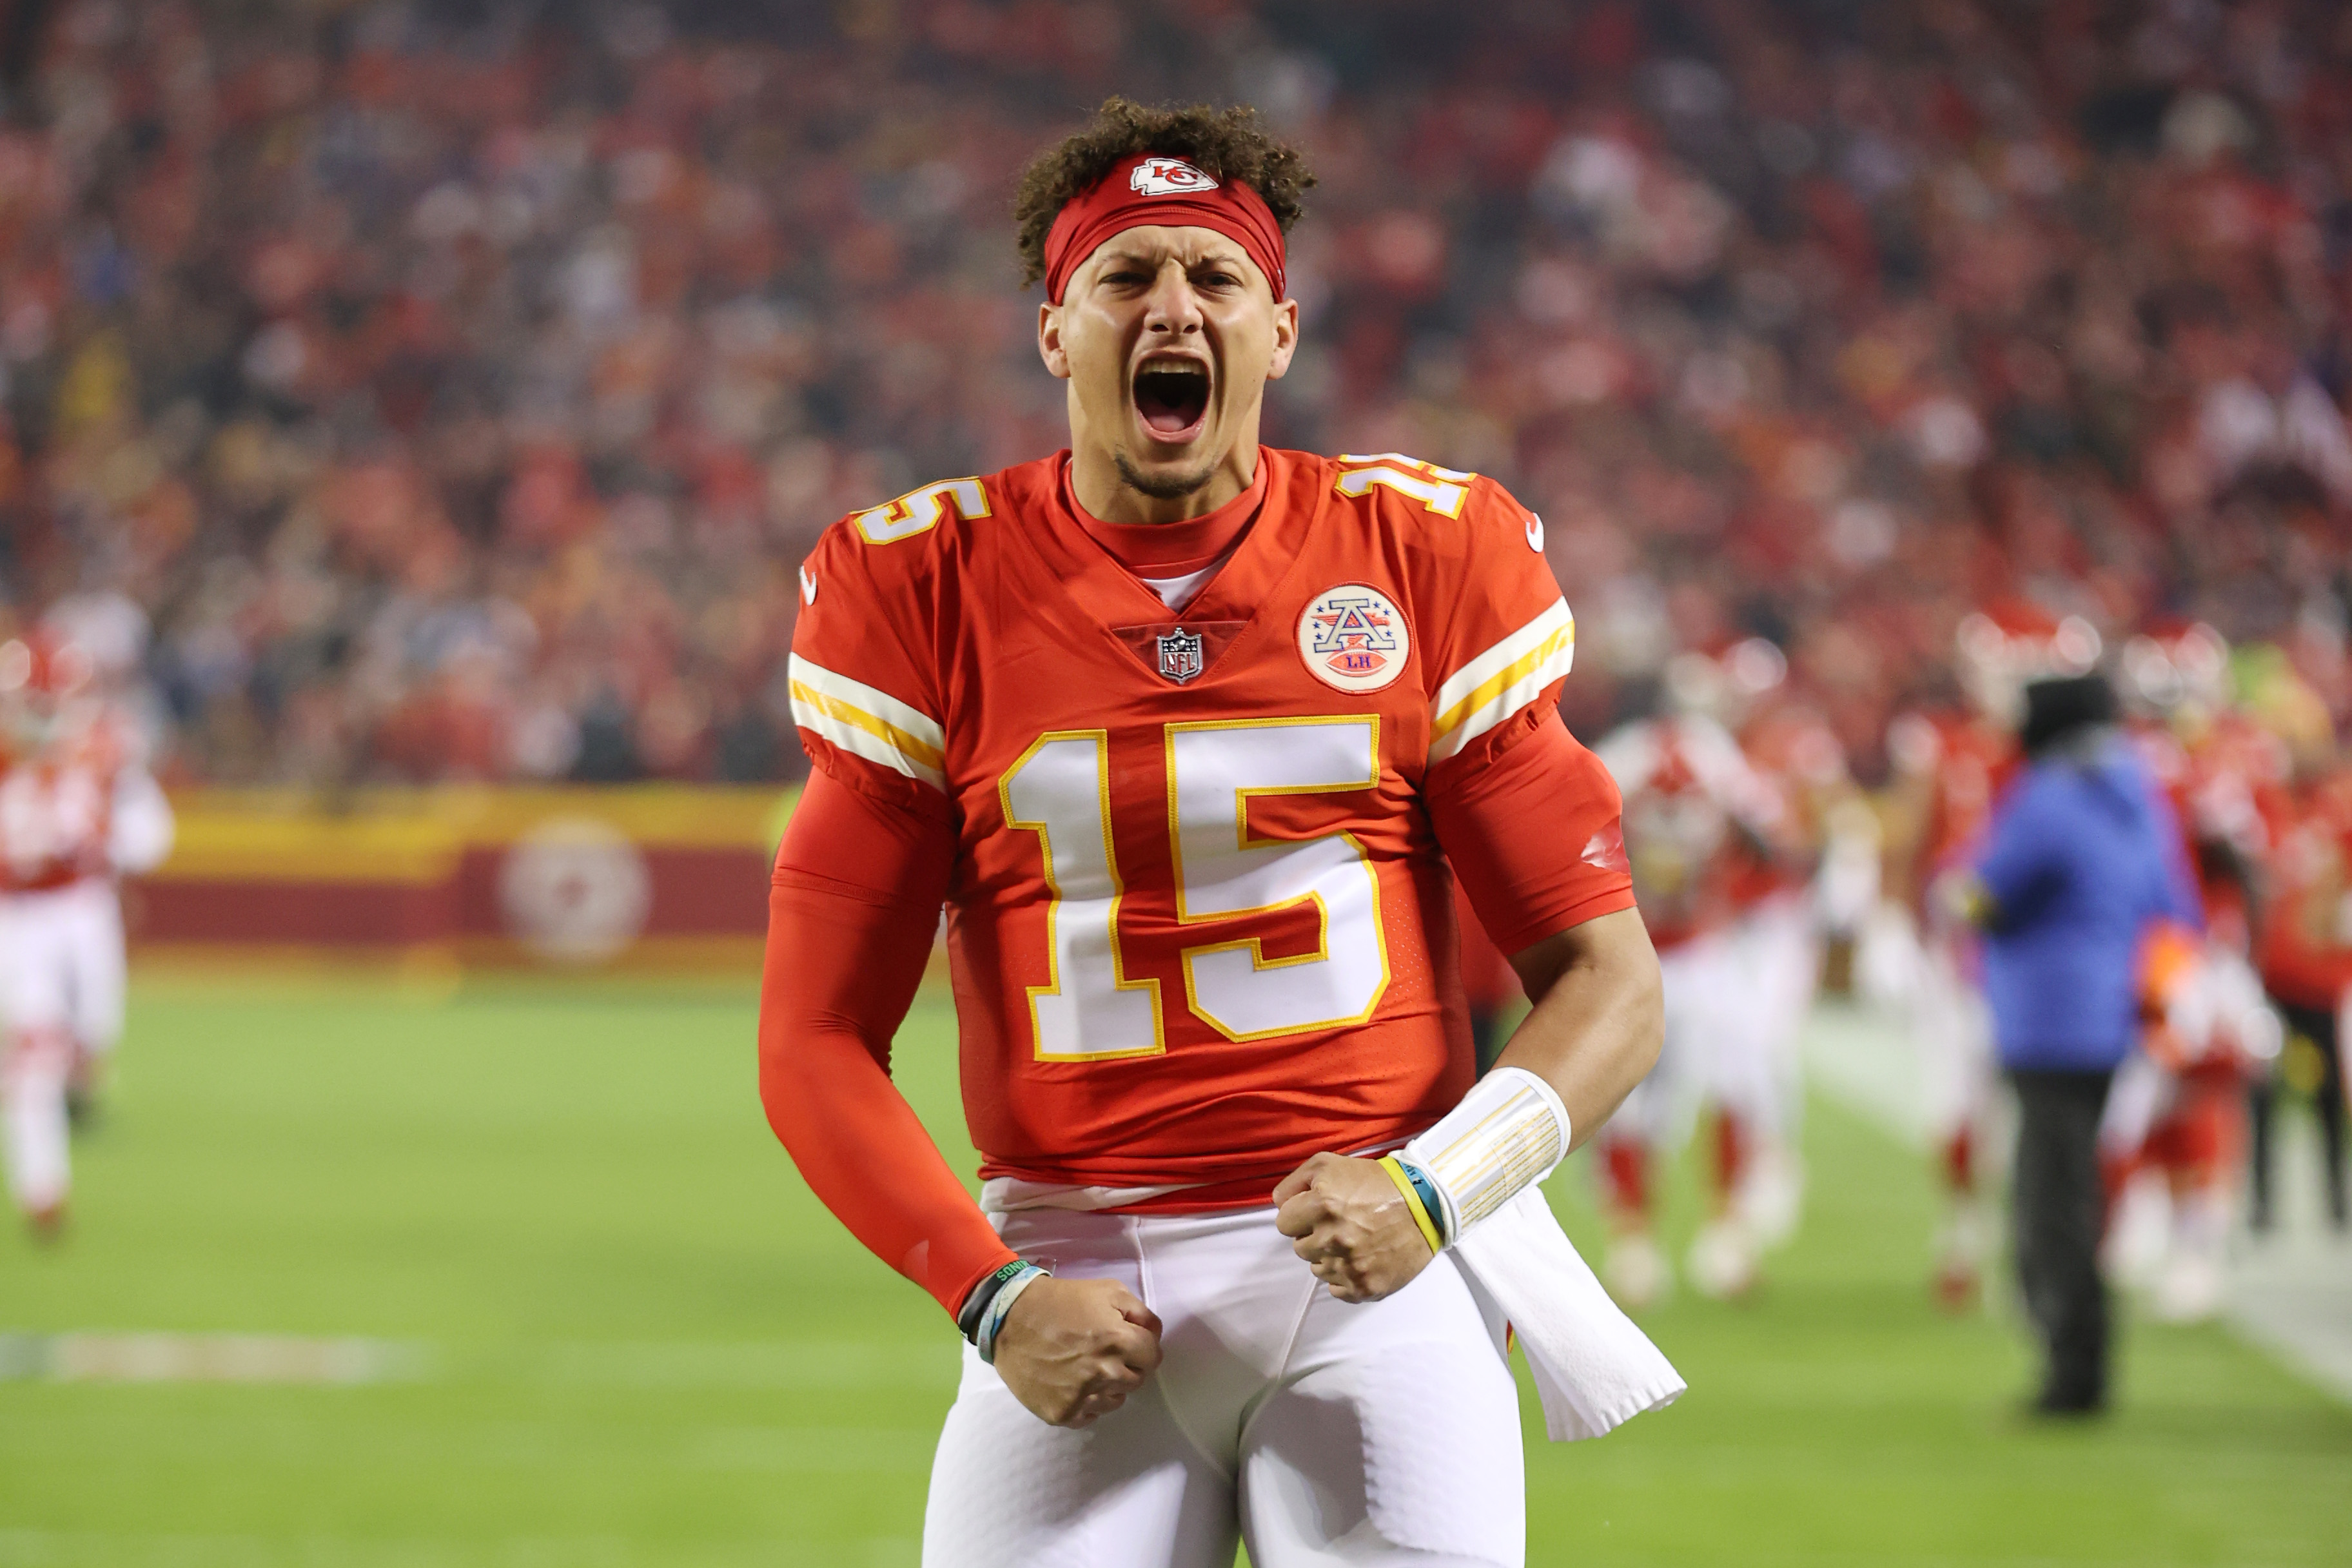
[790,449,1630,1187]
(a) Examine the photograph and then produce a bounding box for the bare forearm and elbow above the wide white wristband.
[1496,910,1665,1147]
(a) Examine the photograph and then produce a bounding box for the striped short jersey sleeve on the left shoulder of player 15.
[790,500,955,816]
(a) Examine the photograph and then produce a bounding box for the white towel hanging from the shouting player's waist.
[1453,1187,1689,1444]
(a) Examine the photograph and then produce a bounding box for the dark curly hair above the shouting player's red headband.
[1014,96,1315,289]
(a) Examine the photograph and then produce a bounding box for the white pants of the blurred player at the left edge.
[0,877,122,1211]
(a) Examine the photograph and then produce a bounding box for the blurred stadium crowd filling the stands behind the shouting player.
[0,0,2352,785]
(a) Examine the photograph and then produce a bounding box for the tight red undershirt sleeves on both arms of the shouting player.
[760,703,1632,1317]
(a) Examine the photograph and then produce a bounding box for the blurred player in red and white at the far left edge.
[0,630,172,1234]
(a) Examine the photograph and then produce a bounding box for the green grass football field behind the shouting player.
[0,980,2352,1568]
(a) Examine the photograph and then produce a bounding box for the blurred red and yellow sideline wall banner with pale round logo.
[127,785,795,966]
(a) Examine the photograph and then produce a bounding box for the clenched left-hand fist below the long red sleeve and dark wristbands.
[995,1277,1159,1427]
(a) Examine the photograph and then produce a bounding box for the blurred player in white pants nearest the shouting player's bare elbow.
[1594,651,1801,1307]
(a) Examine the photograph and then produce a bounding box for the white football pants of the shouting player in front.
[922,1208,1527,1568]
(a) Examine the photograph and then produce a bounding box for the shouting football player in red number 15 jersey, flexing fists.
[760,99,1681,1568]
